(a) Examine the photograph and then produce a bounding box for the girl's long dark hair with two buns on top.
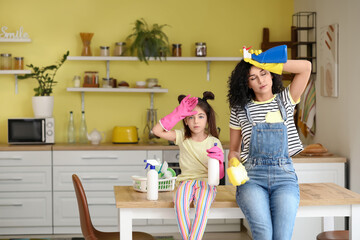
[178,91,219,139]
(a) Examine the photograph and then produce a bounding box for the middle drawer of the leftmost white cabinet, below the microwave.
[0,166,52,192]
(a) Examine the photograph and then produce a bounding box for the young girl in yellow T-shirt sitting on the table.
[153,92,224,240]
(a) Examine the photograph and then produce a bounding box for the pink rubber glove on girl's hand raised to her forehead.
[159,95,198,131]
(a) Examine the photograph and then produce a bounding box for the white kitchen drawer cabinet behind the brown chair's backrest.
[53,150,148,234]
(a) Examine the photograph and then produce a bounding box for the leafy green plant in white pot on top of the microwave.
[18,51,69,117]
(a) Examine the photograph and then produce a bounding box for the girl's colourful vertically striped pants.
[174,180,216,240]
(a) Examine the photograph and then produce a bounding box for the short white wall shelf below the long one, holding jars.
[66,87,168,93]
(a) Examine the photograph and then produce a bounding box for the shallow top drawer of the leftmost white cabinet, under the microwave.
[0,151,51,166]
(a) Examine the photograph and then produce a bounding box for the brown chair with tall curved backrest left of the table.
[72,174,155,240]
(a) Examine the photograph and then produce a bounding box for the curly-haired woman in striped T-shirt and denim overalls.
[228,47,311,240]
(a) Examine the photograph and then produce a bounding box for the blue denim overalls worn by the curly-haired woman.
[236,95,300,240]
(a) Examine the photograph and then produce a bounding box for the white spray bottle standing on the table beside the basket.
[144,159,160,201]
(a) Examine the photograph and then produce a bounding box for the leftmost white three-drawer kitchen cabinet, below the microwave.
[0,150,53,235]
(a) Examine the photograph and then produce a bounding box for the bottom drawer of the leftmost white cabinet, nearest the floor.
[0,192,52,228]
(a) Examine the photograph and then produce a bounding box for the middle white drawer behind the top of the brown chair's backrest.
[53,165,145,191]
